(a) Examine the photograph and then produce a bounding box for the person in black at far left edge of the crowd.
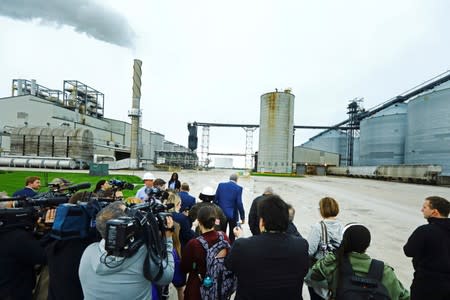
[0,198,46,300]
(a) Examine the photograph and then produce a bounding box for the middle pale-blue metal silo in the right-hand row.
[359,103,408,166]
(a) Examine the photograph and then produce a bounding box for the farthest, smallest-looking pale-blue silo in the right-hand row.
[302,130,347,165]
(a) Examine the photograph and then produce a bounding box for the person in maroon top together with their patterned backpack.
[181,205,236,300]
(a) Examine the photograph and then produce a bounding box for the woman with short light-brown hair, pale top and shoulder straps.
[308,197,344,300]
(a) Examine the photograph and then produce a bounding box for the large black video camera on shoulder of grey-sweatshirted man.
[105,202,173,257]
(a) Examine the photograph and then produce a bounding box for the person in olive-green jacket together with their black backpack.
[305,223,410,300]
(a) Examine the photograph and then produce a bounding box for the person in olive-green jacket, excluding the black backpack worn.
[305,223,409,300]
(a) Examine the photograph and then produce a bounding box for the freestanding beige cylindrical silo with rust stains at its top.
[257,90,295,173]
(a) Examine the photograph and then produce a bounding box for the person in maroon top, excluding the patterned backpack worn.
[181,206,230,300]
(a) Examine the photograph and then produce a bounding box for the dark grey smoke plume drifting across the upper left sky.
[0,0,135,48]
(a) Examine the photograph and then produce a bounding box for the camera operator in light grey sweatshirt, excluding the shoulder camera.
[79,201,174,300]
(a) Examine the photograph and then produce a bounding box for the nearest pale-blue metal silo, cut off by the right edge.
[405,82,450,175]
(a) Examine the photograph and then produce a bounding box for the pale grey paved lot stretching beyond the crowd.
[125,170,450,299]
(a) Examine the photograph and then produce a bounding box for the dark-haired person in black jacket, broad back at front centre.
[225,195,308,300]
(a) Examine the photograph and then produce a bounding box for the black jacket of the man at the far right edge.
[403,218,450,283]
